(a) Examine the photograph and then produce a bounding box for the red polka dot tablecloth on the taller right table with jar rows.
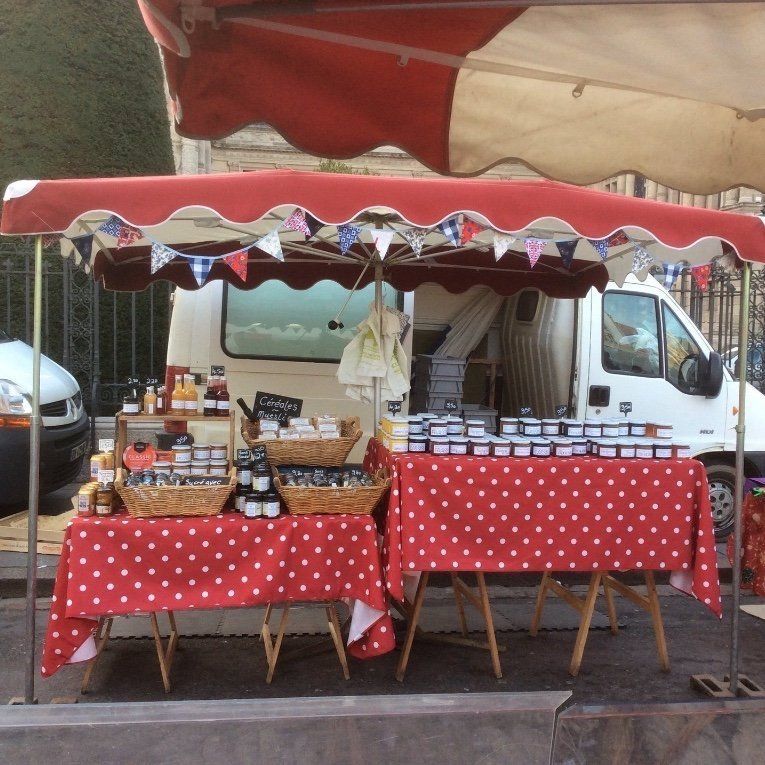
[365,439,722,616]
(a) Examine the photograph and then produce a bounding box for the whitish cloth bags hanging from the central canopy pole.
[337,307,409,403]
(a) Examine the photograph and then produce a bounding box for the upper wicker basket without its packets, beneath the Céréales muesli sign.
[242,417,362,467]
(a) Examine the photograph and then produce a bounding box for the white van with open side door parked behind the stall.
[168,277,765,537]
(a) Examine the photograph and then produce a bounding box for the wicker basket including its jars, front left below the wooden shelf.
[114,470,236,518]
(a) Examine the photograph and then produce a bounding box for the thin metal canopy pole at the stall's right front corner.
[730,261,752,696]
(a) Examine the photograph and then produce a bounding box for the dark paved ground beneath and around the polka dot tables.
[0,587,765,704]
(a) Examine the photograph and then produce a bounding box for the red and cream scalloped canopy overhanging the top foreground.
[138,0,765,194]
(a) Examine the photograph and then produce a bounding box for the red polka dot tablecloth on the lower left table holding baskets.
[42,513,395,677]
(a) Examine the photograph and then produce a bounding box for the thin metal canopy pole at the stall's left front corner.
[24,234,42,704]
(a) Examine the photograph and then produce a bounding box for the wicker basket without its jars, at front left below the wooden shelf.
[114,471,236,518]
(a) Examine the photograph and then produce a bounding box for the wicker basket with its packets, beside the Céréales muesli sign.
[242,416,362,467]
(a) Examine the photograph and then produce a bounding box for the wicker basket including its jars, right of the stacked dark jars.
[273,468,390,515]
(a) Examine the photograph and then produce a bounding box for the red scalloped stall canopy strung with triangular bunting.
[0,170,765,297]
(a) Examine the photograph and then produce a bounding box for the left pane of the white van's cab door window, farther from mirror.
[603,292,661,377]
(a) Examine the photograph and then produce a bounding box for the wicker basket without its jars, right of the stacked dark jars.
[274,470,390,515]
